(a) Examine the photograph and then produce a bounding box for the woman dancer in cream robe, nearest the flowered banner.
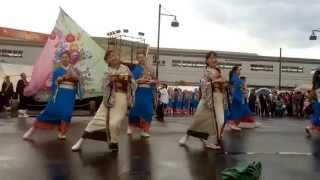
[72,48,136,152]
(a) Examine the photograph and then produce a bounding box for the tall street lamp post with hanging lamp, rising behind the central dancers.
[155,4,179,79]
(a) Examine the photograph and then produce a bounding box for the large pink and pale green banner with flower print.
[25,9,107,98]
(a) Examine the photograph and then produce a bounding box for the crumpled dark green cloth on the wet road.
[221,162,262,180]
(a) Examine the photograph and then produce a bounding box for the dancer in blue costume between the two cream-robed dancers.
[128,50,156,138]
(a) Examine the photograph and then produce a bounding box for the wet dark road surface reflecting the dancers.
[0,113,320,180]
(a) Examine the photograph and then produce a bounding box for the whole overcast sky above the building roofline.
[0,0,320,59]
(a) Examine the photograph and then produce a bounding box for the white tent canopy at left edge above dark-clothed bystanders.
[0,63,32,88]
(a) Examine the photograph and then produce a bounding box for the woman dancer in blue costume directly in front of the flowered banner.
[23,51,79,140]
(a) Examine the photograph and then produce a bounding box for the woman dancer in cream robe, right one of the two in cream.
[179,51,225,149]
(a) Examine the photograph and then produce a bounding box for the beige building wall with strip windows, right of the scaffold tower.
[149,48,320,88]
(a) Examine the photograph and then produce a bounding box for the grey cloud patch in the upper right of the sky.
[194,0,320,48]
